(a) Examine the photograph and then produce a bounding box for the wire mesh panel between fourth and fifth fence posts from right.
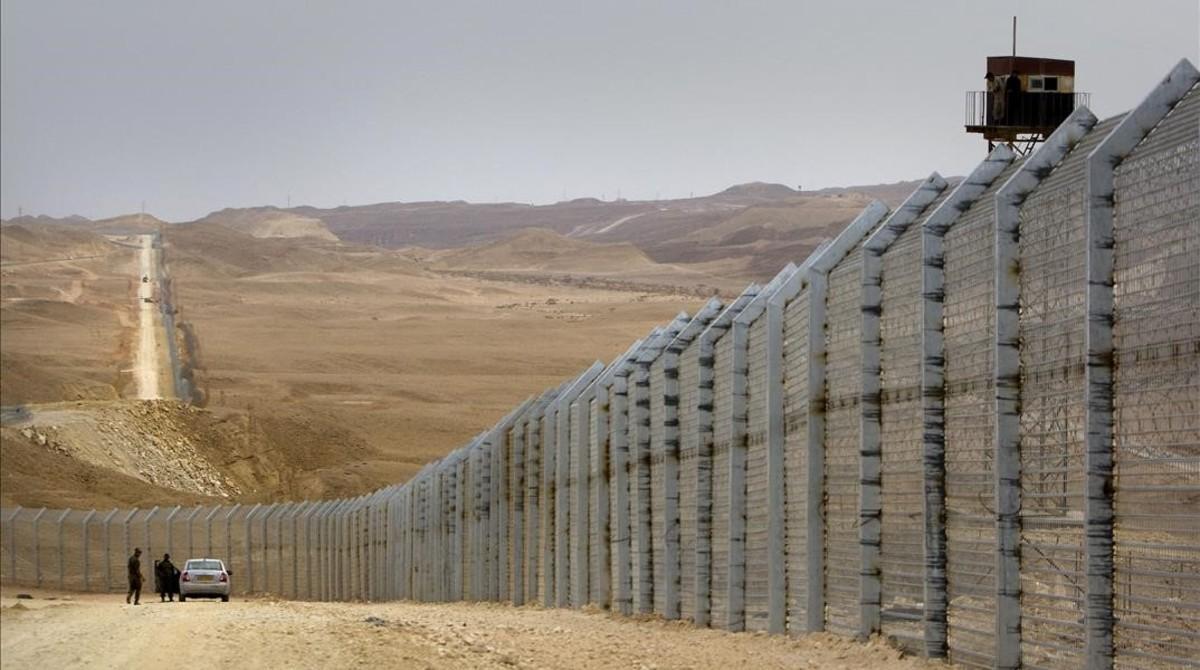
[824,246,863,635]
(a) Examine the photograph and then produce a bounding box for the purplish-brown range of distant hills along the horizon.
[202,181,919,281]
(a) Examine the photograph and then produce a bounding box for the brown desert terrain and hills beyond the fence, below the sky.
[0,178,908,508]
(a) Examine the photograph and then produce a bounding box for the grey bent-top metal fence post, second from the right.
[994,107,1096,669]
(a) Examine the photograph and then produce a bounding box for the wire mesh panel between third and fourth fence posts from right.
[880,214,931,653]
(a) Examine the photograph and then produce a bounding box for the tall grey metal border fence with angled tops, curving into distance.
[0,60,1200,669]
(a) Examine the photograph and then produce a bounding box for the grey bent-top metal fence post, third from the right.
[920,144,1016,658]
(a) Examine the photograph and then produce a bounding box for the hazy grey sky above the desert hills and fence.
[0,0,1200,221]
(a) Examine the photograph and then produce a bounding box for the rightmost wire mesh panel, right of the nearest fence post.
[1112,88,1200,668]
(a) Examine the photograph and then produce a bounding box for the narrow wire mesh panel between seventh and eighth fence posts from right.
[710,334,733,628]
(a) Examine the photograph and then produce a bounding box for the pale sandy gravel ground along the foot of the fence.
[0,588,946,670]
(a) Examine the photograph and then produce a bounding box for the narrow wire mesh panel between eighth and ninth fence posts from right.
[679,342,712,620]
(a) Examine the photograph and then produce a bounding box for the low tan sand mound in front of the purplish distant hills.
[433,228,655,274]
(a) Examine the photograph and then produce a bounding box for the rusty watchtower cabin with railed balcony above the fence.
[966,55,1090,154]
